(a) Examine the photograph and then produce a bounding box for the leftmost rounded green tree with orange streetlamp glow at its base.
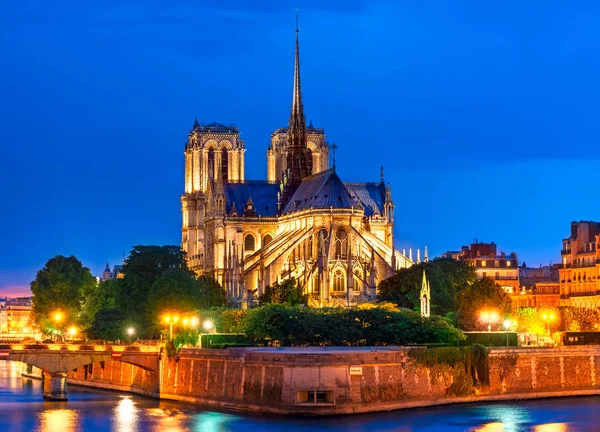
[31,255,96,329]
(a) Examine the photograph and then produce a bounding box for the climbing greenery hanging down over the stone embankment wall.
[409,344,489,396]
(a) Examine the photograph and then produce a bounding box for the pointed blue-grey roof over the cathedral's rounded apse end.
[283,168,361,214]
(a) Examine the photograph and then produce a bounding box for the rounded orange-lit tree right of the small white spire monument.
[457,277,512,330]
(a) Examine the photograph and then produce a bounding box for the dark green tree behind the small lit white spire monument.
[378,258,477,315]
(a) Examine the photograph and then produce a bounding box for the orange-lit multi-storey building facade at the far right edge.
[558,221,600,308]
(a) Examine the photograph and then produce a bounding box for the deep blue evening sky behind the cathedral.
[0,0,600,294]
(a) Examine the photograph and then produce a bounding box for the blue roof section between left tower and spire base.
[225,180,279,216]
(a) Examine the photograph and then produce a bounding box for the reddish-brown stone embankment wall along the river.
[62,346,600,415]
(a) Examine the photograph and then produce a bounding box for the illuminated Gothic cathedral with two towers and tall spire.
[181,25,413,307]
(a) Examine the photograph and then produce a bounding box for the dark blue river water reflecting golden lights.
[0,361,600,432]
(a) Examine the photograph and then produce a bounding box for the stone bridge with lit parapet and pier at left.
[0,344,162,400]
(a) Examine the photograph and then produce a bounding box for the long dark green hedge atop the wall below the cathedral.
[242,304,464,346]
